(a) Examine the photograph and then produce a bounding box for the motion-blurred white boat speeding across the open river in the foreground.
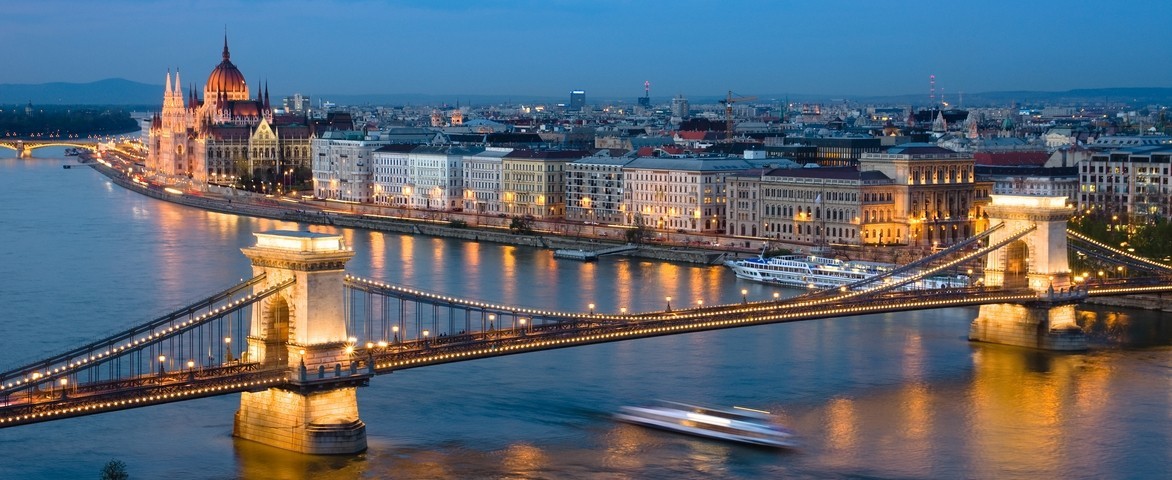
[615,402,797,447]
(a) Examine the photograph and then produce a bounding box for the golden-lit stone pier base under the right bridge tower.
[968,302,1086,351]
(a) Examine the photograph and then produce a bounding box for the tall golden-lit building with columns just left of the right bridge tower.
[859,144,993,247]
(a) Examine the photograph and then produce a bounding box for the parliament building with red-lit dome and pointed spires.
[145,36,313,186]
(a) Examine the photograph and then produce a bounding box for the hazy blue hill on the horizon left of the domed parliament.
[0,78,163,105]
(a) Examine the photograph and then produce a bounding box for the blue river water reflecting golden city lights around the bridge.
[0,150,1172,479]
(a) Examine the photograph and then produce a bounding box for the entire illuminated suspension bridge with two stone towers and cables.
[0,196,1172,454]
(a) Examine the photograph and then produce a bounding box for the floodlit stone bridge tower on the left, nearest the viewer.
[233,231,370,454]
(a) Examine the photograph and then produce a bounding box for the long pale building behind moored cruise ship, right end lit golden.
[724,166,908,246]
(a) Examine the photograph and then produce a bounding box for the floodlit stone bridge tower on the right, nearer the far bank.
[968,194,1086,350]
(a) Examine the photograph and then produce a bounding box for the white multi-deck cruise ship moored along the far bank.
[724,255,969,290]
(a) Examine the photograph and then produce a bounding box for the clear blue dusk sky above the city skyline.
[9,0,1172,98]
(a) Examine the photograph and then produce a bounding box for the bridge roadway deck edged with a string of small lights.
[0,277,1172,428]
